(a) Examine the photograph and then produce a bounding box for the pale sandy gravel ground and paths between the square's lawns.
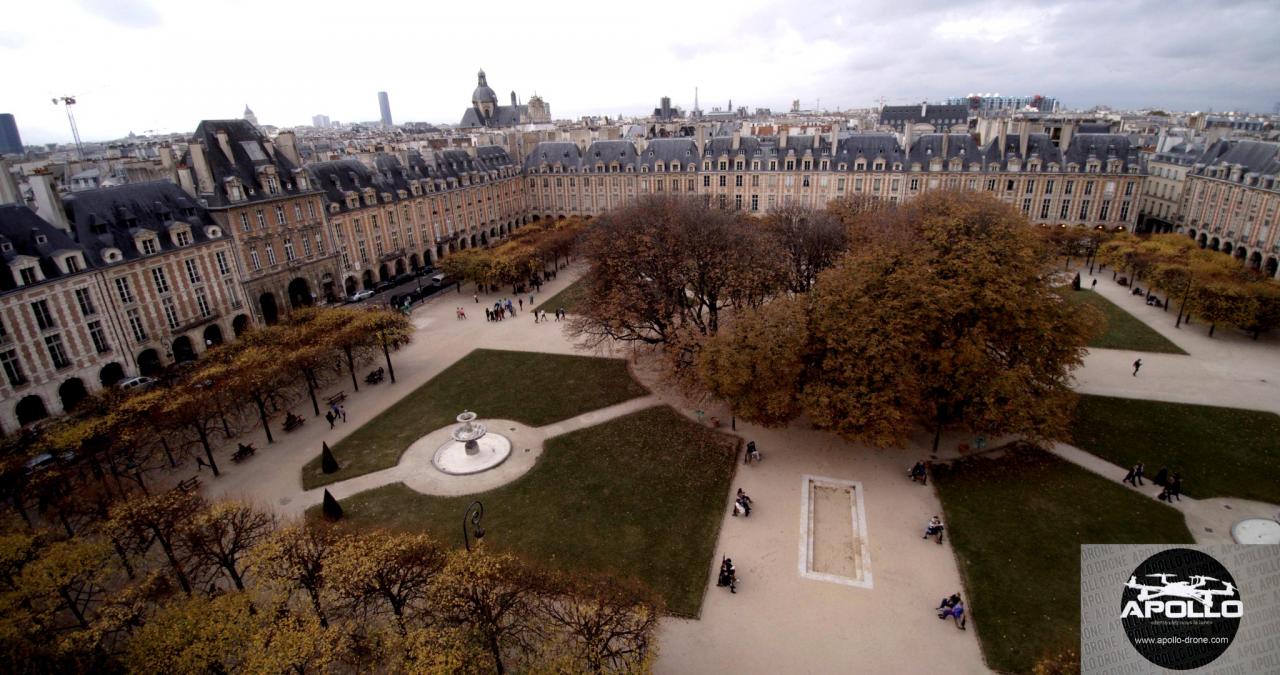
[197,262,1280,674]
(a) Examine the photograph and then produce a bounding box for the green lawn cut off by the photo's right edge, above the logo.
[1071,396,1280,503]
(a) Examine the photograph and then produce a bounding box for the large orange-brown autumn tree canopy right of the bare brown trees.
[699,192,1100,446]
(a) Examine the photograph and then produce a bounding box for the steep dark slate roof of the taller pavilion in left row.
[187,119,311,207]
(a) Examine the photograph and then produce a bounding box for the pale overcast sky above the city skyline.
[0,0,1280,143]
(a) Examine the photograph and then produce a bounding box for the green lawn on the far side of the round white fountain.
[302,350,649,489]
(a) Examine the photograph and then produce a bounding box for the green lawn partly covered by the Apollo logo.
[933,451,1193,672]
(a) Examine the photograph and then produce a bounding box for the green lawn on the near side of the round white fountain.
[308,406,736,616]
